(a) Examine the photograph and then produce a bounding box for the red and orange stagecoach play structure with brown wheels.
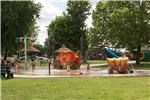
[53,51,81,70]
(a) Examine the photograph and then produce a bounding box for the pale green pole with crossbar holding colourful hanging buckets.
[16,35,35,70]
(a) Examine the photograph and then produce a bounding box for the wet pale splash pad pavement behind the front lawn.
[14,64,150,78]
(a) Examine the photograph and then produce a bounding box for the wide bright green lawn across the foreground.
[0,77,150,100]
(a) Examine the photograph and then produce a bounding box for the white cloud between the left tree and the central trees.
[34,0,62,45]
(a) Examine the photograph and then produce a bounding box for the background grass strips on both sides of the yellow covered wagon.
[92,63,150,70]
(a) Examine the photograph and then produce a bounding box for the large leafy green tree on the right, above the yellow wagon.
[91,0,150,64]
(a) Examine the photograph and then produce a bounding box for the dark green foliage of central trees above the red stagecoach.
[48,0,91,51]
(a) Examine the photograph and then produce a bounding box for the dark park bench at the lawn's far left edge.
[0,66,14,79]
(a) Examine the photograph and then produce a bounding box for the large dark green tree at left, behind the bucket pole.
[0,0,42,58]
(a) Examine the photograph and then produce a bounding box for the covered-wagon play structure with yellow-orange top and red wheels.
[107,57,130,74]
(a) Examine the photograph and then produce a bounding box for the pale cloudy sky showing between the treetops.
[34,0,99,45]
